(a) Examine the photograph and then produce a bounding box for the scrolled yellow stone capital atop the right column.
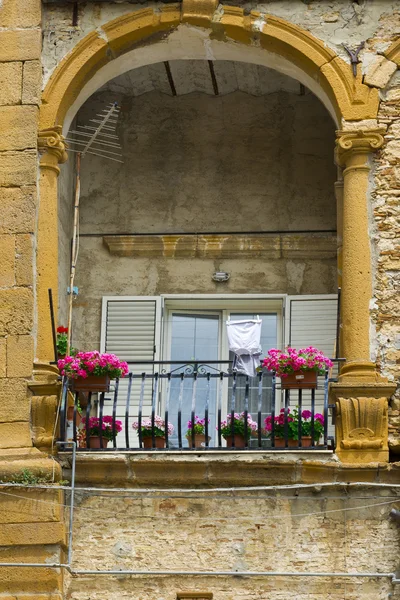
[335,127,386,167]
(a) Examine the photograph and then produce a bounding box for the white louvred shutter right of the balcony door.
[285,295,338,434]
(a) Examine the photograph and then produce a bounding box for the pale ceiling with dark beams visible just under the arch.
[98,60,308,96]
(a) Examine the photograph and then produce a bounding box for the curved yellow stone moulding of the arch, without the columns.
[40,5,379,130]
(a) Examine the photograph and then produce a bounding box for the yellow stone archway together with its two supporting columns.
[36,0,392,460]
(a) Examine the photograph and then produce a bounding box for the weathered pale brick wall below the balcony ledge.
[67,476,400,600]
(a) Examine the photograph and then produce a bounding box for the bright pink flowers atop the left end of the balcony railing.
[57,351,129,379]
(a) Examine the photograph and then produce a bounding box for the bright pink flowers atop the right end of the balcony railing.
[263,346,333,377]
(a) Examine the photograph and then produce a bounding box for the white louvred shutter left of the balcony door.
[101,296,162,447]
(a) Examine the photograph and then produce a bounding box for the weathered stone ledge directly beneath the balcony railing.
[60,450,400,488]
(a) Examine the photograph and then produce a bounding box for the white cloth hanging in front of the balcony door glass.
[226,319,262,377]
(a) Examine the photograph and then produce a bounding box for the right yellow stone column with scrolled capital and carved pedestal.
[330,129,395,463]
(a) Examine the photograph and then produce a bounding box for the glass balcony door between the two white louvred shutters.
[161,301,279,445]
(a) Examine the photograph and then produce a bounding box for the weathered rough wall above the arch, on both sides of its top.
[43,0,400,88]
